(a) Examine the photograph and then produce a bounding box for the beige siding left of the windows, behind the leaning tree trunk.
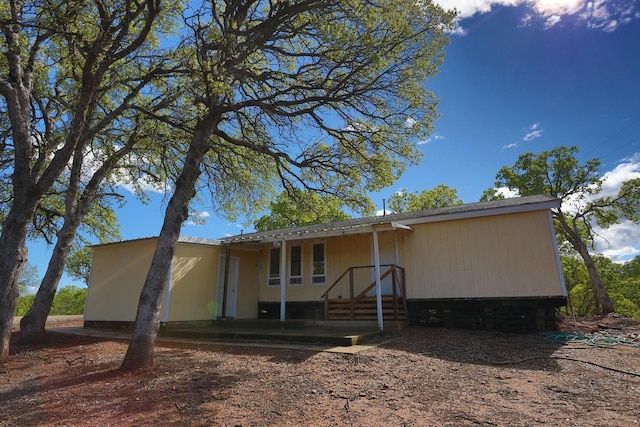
[85,239,259,322]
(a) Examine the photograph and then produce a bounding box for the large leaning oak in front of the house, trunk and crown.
[122,0,454,369]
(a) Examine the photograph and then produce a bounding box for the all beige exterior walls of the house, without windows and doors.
[85,206,564,322]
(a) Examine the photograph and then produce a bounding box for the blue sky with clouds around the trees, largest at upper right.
[30,0,640,286]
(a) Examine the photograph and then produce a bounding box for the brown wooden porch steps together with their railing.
[322,264,408,320]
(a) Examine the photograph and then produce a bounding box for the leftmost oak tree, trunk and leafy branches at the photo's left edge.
[0,0,165,360]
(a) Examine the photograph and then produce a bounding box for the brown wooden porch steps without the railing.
[327,295,408,320]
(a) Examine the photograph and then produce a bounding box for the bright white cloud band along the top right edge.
[436,0,640,35]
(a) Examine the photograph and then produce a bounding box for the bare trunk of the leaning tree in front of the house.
[120,126,214,370]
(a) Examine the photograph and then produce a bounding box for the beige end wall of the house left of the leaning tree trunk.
[85,239,159,322]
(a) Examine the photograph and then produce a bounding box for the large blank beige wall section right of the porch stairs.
[400,210,563,299]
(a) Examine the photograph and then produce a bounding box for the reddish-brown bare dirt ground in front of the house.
[0,316,640,426]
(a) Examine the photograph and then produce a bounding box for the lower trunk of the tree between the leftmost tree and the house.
[20,218,80,343]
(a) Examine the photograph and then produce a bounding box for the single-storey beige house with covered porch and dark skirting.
[85,196,567,329]
